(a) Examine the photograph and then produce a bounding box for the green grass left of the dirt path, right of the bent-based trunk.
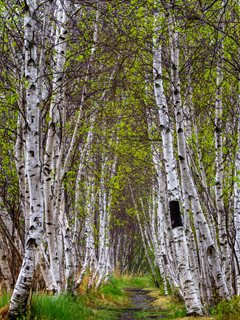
[29,276,152,320]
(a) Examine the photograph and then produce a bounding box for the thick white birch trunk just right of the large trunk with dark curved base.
[44,0,69,292]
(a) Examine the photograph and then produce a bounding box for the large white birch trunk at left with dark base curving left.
[9,0,43,319]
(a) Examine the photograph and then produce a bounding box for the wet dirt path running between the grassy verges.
[119,289,166,320]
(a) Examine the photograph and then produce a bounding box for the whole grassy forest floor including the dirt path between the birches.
[0,276,213,320]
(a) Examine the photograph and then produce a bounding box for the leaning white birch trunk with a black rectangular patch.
[153,11,203,314]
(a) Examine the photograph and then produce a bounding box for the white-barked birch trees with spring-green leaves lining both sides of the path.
[0,0,240,319]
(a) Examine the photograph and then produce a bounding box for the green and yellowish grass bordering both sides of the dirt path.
[0,276,193,320]
